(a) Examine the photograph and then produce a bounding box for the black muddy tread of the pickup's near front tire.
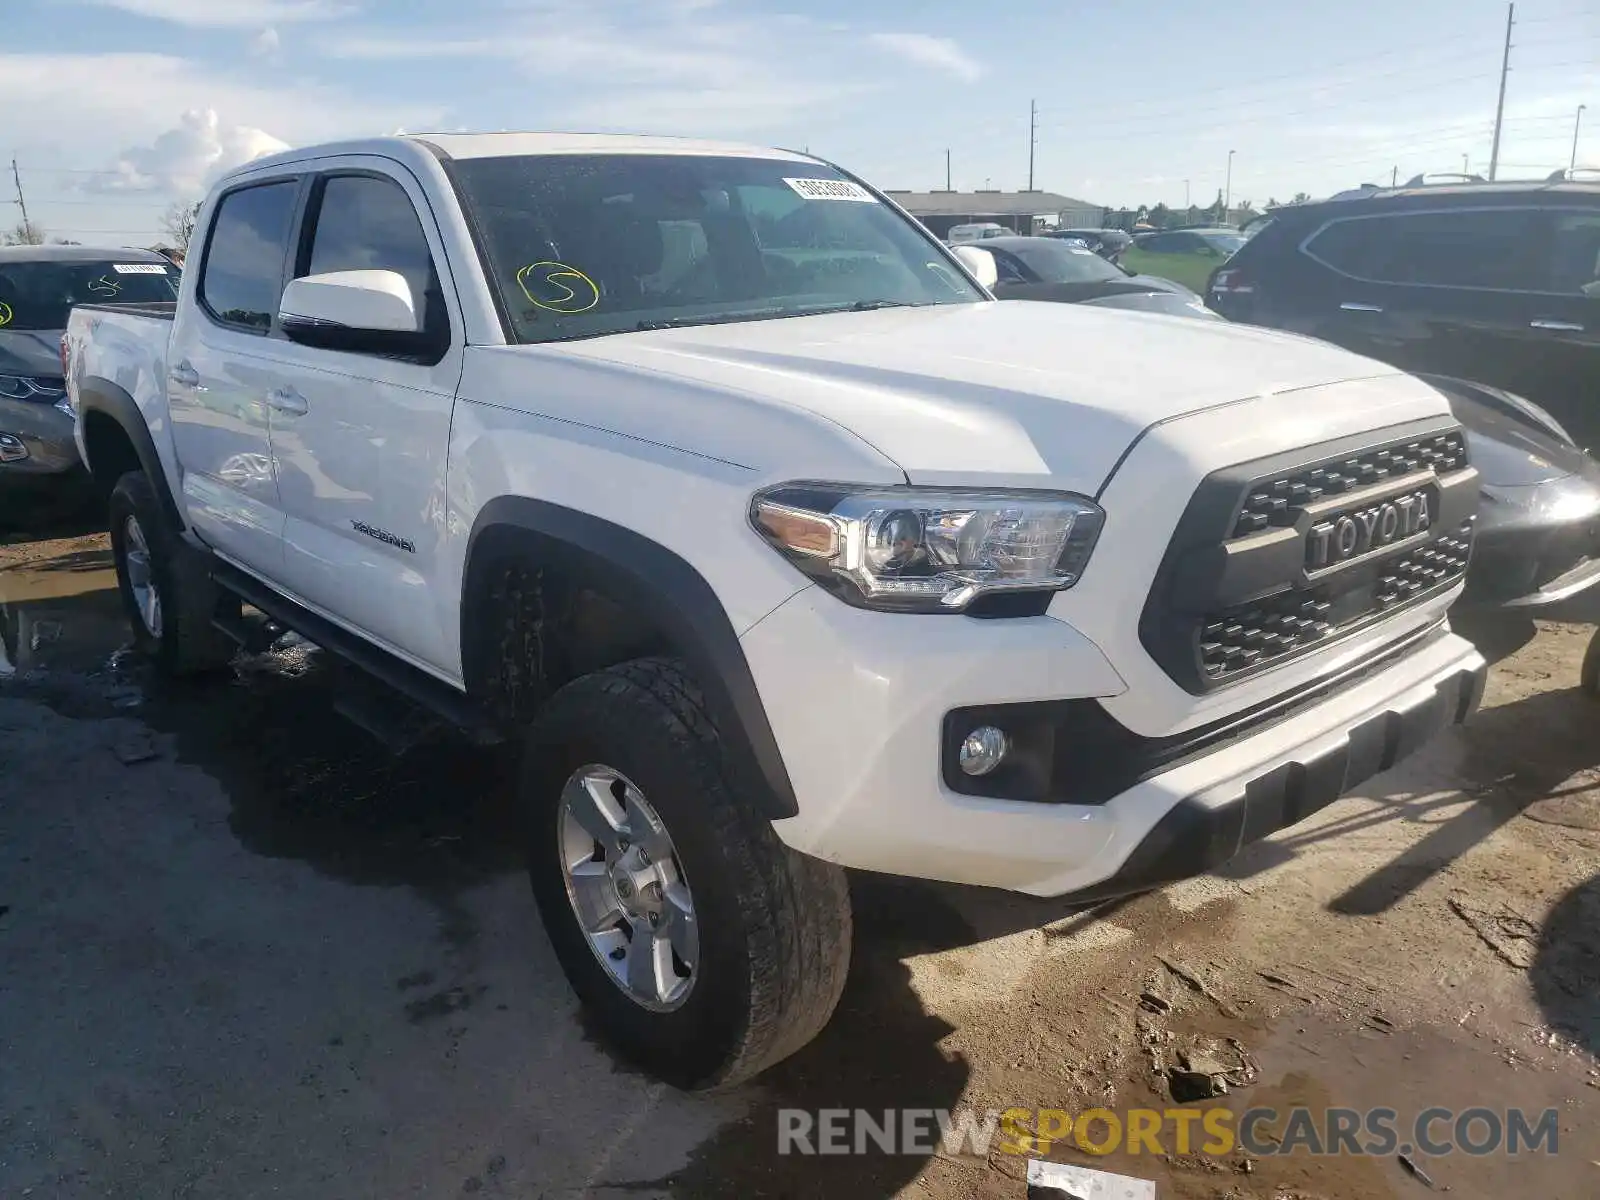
[524,658,851,1088]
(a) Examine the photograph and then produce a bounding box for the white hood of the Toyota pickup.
[534,301,1445,491]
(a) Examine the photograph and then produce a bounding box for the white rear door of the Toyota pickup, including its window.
[166,178,301,576]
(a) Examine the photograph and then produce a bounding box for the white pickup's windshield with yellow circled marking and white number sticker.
[453,154,982,342]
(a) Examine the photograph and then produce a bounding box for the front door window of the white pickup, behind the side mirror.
[294,174,445,328]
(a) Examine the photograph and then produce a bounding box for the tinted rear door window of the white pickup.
[200,179,299,333]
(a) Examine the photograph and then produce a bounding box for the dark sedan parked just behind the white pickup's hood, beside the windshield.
[982,237,1214,317]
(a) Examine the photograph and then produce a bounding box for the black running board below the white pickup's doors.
[211,558,504,746]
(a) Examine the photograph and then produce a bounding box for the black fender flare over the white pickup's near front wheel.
[461,496,800,821]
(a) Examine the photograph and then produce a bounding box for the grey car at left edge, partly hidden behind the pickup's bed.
[0,246,178,482]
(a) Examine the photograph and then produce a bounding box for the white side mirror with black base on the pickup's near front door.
[278,270,429,355]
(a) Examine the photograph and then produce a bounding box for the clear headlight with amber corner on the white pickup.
[750,483,1106,613]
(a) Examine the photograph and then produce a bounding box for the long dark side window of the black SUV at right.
[1306,208,1541,291]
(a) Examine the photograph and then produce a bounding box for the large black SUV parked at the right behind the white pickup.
[1205,178,1600,448]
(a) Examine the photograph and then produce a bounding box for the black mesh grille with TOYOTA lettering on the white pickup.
[1139,421,1478,694]
